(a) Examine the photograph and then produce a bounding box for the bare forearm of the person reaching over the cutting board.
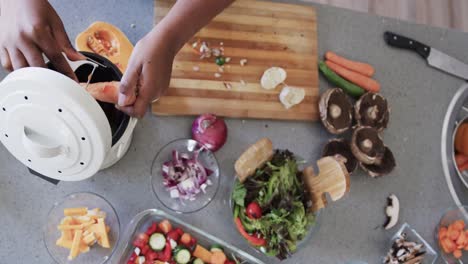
[153,0,234,53]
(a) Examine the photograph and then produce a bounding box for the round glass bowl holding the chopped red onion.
[151,139,219,213]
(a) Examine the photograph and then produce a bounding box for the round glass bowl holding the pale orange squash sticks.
[44,192,120,264]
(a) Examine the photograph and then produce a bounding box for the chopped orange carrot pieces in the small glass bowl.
[437,219,468,259]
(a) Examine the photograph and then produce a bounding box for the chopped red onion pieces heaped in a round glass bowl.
[162,148,213,201]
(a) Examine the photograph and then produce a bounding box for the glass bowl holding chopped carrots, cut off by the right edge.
[435,206,468,264]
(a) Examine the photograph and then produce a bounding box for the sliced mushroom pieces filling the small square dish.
[384,233,426,264]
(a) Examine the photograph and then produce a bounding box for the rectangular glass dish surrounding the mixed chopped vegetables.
[114,209,265,264]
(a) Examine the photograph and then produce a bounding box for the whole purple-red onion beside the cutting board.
[192,114,227,151]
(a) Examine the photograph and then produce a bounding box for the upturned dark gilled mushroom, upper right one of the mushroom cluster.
[354,93,390,132]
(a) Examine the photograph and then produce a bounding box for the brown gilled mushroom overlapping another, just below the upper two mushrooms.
[351,127,385,164]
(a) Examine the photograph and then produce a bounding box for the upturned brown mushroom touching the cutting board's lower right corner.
[319,88,353,134]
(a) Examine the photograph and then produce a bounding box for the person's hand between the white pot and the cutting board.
[117,28,177,118]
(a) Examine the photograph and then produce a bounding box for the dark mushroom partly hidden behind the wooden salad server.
[322,139,358,174]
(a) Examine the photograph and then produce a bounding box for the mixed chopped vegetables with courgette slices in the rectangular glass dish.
[127,220,240,264]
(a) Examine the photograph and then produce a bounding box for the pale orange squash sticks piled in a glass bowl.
[55,207,111,260]
